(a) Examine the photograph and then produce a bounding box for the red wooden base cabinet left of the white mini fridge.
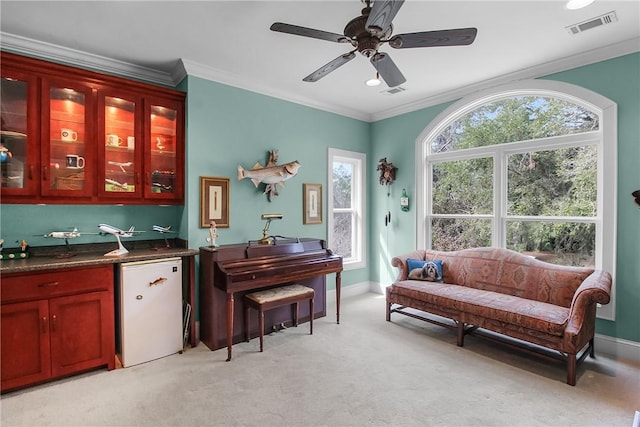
[0,264,115,391]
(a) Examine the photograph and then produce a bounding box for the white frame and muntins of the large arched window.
[415,80,618,321]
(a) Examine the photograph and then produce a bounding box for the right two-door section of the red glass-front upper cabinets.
[98,91,184,202]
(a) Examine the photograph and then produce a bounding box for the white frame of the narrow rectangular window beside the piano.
[327,148,367,270]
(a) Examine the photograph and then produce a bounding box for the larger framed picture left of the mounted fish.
[200,176,229,228]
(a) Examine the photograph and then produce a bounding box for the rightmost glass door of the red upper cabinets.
[145,101,183,199]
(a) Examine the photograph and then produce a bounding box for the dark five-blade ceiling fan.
[271,0,478,87]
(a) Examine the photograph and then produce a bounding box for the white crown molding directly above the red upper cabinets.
[0,32,180,87]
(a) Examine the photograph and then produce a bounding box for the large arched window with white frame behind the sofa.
[416,80,617,320]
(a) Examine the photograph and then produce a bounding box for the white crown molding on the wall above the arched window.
[370,37,640,122]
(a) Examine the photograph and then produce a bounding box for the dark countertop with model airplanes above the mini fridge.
[0,240,199,274]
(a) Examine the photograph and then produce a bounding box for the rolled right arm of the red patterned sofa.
[565,270,611,342]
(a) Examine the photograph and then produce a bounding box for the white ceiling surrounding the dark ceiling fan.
[0,0,640,121]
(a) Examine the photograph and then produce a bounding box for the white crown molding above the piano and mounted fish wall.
[178,58,371,122]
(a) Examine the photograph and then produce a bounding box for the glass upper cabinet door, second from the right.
[99,95,142,198]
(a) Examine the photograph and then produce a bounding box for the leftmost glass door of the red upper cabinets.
[0,70,38,196]
